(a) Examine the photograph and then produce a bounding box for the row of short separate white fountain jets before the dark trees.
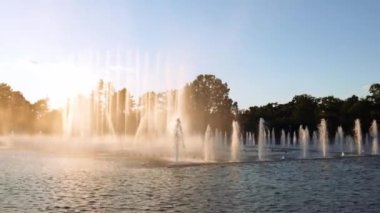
[199,118,378,161]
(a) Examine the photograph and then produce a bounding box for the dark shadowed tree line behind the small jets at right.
[238,83,380,141]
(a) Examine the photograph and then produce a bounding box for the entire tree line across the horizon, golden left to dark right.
[0,75,380,140]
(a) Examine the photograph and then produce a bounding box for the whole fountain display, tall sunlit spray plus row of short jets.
[2,50,378,167]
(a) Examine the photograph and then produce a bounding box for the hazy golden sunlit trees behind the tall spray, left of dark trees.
[0,75,236,135]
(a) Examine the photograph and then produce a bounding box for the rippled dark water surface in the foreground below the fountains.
[0,151,380,212]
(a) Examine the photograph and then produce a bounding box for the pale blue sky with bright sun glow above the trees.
[0,0,380,108]
